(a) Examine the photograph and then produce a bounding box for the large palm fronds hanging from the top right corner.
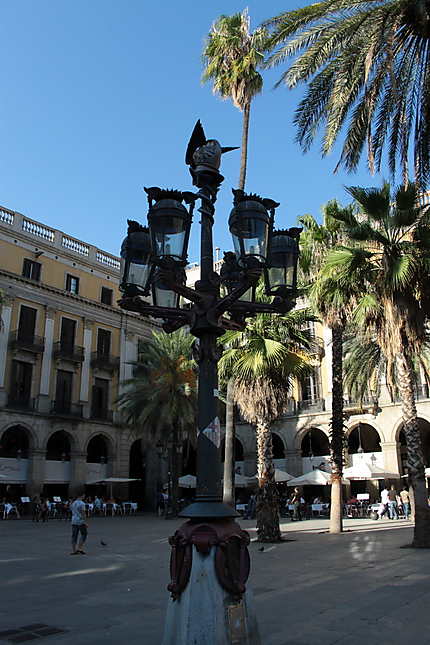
[265,0,430,187]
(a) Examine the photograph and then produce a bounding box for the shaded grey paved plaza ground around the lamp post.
[0,515,430,645]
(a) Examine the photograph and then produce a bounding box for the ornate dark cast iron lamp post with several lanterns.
[119,121,301,645]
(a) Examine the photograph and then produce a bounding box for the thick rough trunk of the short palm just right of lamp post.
[256,422,281,542]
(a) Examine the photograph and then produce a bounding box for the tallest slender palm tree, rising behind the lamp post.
[202,9,266,506]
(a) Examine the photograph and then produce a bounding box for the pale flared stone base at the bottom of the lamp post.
[162,546,261,645]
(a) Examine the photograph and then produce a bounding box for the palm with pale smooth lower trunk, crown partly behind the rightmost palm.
[299,200,354,533]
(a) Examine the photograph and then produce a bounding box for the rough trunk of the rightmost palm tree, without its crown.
[396,351,430,548]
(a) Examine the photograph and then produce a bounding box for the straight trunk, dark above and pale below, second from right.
[329,324,344,533]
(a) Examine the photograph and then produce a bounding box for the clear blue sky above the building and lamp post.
[0,0,381,261]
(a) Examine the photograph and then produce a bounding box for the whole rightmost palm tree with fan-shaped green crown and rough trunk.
[325,183,430,547]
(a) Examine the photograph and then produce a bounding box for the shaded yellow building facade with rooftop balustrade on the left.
[0,208,155,504]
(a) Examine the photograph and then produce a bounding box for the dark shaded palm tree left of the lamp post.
[117,329,197,514]
